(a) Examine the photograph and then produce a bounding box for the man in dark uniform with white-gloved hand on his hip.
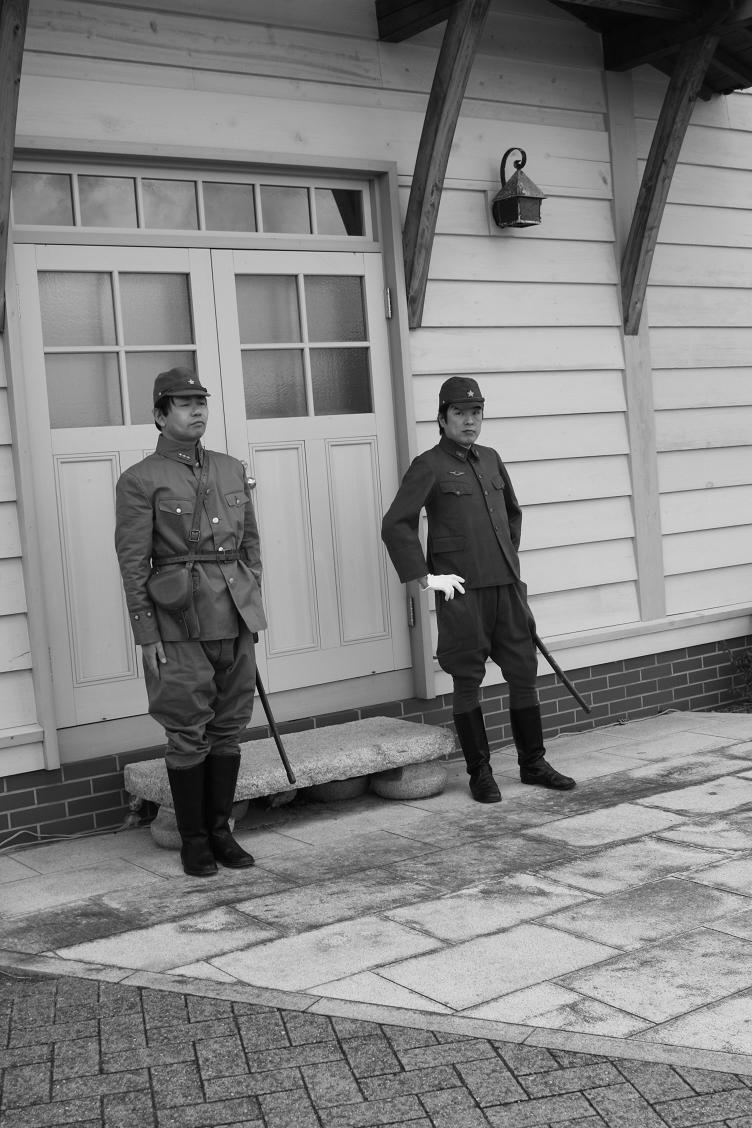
[381,376,575,803]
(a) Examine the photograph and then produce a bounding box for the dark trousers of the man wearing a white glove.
[436,584,538,713]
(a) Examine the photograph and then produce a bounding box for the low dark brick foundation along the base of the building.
[0,635,752,847]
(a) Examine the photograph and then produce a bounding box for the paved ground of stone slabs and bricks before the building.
[0,713,752,1128]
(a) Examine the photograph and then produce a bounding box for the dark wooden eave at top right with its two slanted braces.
[375,0,752,335]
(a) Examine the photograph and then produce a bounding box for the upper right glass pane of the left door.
[120,274,193,345]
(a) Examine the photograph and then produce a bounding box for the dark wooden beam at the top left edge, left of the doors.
[0,0,28,333]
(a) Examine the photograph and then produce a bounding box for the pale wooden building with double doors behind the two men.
[0,0,752,838]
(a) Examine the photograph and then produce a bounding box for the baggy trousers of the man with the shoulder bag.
[145,626,256,768]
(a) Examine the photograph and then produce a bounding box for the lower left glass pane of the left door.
[45,353,123,428]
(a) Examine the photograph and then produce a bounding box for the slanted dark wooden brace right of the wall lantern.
[621,30,719,336]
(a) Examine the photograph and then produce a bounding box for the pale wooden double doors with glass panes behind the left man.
[16,245,409,728]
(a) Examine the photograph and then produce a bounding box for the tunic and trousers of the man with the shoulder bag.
[115,434,266,767]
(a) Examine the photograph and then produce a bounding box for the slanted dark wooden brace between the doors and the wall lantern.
[402,0,490,329]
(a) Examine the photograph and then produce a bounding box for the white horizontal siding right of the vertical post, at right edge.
[635,73,752,615]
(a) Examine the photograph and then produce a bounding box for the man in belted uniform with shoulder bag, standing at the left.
[115,368,266,876]
